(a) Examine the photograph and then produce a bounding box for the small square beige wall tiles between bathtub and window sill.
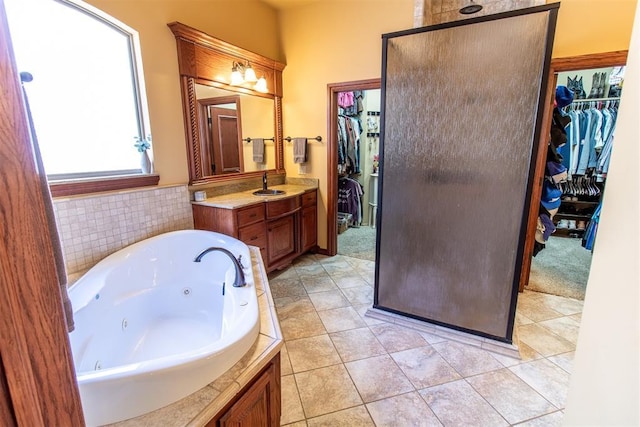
[53,185,193,283]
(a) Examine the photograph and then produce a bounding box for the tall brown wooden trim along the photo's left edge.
[0,1,84,426]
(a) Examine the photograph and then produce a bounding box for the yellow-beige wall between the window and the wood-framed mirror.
[88,0,282,184]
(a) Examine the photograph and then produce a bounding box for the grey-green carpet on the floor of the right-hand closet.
[527,236,591,300]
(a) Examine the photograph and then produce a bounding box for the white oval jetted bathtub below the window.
[69,230,260,425]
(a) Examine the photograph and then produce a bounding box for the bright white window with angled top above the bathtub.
[5,0,157,195]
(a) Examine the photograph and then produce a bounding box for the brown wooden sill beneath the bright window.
[49,174,160,197]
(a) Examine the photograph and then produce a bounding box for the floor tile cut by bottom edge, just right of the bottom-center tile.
[367,392,442,427]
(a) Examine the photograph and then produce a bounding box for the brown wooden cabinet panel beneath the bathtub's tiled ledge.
[207,353,282,427]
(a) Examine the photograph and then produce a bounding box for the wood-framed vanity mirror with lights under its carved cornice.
[167,22,284,185]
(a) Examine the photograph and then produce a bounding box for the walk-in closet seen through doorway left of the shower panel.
[335,89,380,261]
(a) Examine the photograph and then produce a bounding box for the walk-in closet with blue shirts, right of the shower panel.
[528,66,625,300]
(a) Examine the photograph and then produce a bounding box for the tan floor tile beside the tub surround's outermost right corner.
[287,334,342,373]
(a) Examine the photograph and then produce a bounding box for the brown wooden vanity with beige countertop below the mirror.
[192,184,317,272]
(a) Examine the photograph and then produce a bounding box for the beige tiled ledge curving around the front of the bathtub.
[109,246,284,427]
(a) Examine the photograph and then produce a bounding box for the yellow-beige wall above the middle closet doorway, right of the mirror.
[280,0,413,248]
